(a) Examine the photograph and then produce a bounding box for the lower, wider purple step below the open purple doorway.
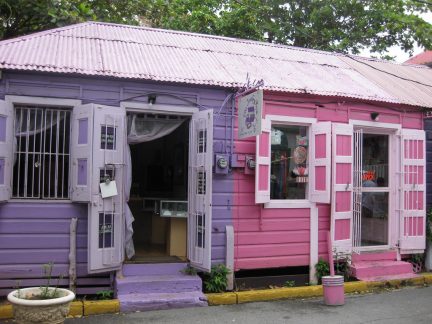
[116,273,202,295]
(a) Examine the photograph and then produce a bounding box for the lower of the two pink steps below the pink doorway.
[351,260,413,279]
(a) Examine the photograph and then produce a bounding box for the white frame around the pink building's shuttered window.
[264,115,317,209]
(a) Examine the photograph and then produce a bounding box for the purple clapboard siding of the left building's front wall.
[0,71,233,292]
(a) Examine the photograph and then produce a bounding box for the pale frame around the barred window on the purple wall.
[5,95,81,203]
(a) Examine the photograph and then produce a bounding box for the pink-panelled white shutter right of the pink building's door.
[398,129,426,250]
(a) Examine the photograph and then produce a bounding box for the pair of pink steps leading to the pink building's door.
[351,251,417,281]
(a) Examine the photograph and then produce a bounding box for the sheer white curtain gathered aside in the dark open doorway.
[125,114,185,259]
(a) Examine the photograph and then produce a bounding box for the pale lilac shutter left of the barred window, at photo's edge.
[0,100,15,202]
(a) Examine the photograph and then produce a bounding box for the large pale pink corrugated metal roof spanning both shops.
[0,22,432,107]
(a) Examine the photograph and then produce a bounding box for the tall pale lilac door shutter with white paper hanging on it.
[88,105,127,273]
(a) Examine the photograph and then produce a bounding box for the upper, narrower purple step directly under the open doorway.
[122,262,187,277]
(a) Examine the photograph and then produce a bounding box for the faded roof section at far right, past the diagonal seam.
[342,57,432,108]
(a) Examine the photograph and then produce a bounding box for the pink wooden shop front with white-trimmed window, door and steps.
[233,91,425,281]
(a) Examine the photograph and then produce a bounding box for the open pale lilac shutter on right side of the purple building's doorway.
[188,110,213,271]
